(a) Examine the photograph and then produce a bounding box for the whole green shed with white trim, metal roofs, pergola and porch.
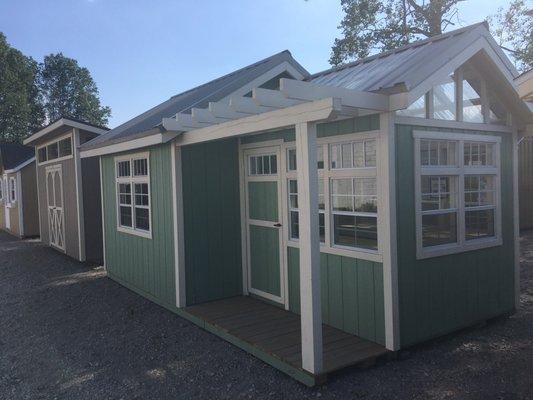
[81,24,532,385]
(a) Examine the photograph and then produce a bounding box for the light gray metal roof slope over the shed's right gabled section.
[307,22,512,92]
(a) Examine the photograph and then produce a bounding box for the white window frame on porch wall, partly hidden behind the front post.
[282,130,378,262]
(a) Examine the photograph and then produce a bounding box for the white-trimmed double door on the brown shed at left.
[46,165,65,251]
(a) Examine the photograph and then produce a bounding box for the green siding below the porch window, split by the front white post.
[287,247,385,344]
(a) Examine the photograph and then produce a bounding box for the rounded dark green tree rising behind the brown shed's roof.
[40,53,111,125]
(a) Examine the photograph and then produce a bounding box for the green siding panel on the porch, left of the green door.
[182,139,242,305]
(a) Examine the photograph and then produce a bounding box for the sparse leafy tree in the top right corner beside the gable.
[487,0,533,71]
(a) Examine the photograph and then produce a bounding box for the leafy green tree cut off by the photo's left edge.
[0,32,44,142]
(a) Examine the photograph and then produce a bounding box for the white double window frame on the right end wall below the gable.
[413,130,503,259]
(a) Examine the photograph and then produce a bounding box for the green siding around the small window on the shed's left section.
[101,145,176,307]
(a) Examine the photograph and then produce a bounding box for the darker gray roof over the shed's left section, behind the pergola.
[82,50,309,150]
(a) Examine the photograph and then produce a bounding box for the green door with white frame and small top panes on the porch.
[244,146,285,304]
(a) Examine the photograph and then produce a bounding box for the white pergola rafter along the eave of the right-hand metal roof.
[280,78,390,111]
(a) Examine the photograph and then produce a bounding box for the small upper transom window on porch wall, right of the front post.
[330,139,376,169]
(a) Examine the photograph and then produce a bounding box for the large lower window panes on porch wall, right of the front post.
[331,178,378,250]
